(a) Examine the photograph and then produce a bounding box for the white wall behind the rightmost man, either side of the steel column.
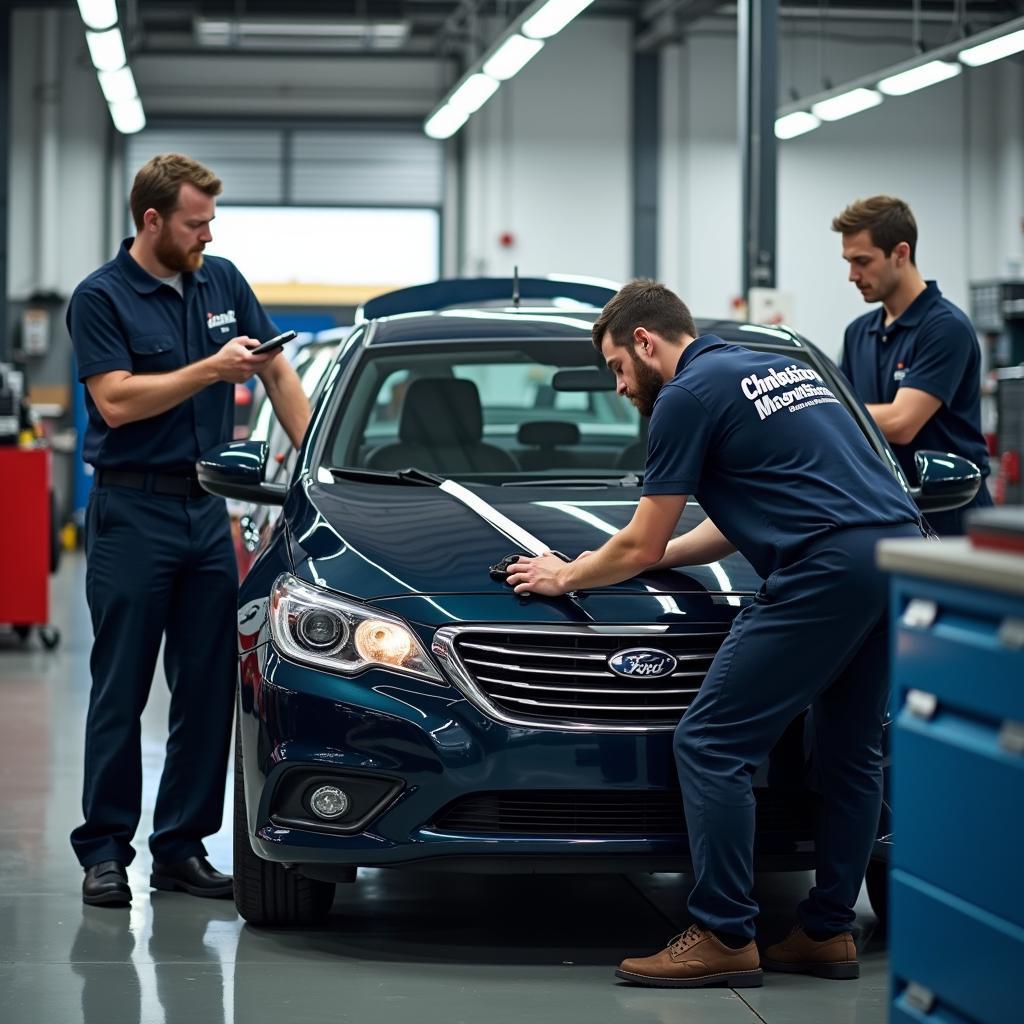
[659,25,1024,354]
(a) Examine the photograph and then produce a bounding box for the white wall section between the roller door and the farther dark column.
[458,18,632,281]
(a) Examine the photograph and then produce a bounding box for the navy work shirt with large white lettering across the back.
[643,335,920,577]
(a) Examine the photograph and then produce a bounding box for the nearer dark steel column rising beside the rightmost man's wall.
[736,0,778,298]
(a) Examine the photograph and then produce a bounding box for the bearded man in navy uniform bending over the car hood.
[508,281,923,987]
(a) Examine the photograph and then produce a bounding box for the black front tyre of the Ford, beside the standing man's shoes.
[233,724,334,928]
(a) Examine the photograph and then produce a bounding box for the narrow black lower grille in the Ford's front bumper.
[431,790,819,844]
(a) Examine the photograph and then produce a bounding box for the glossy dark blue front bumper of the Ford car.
[240,644,814,871]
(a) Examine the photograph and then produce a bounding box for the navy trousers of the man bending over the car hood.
[675,524,921,938]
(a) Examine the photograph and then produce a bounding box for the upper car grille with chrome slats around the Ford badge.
[434,627,728,729]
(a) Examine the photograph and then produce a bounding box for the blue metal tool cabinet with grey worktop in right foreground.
[879,540,1024,1024]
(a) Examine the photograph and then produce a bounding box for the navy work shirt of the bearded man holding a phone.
[68,239,279,473]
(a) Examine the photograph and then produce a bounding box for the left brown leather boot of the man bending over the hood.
[615,925,763,988]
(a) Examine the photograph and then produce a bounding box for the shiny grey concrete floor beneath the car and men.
[0,556,888,1024]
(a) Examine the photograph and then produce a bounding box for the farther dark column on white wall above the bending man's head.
[633,51,662,278]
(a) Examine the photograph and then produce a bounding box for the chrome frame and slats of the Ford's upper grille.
[431,623,729,734]
